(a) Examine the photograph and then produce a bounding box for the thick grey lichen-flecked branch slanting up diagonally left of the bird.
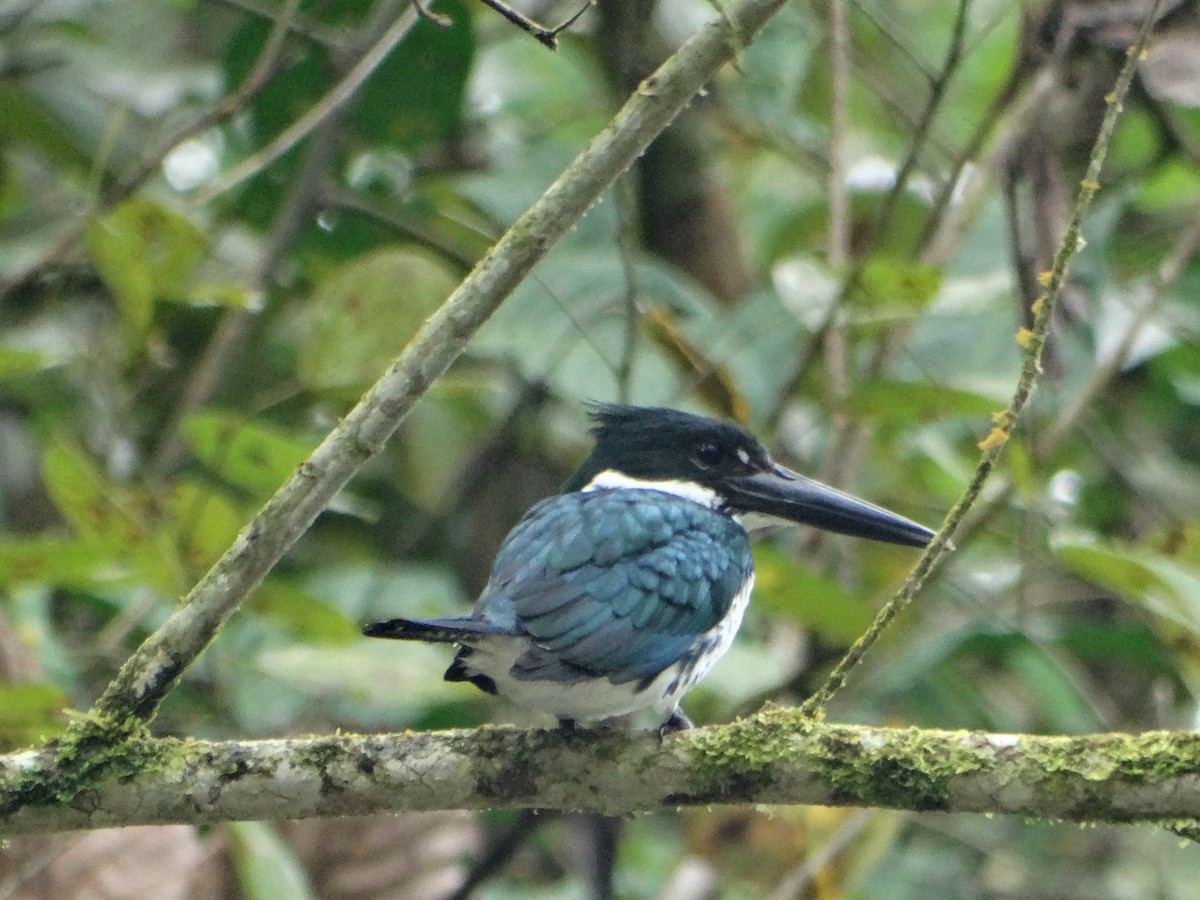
[84,0,785,733]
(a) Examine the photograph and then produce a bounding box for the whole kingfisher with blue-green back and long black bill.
[364,404,934,737]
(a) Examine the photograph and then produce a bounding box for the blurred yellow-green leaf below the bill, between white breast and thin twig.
[754,544,874,644]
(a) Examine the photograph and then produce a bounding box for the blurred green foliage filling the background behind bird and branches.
[0,0,1200,898]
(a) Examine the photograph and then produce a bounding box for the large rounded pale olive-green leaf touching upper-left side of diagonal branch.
[298,246,458,389]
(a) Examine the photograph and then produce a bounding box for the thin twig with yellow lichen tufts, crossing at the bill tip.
[802,0,1162,718]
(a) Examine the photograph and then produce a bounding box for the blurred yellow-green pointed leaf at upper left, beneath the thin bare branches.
[84,197,208,337]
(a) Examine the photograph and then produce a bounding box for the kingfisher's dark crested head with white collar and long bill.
[565,404,934,547]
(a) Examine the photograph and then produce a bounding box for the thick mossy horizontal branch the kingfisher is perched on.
[0,710,1200,836]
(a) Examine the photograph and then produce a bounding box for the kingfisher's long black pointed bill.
[728,466,934,547]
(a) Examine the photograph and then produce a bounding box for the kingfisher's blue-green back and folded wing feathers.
[476,490,752,684]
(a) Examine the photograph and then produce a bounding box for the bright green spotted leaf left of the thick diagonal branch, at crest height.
[182,410,313,497]
